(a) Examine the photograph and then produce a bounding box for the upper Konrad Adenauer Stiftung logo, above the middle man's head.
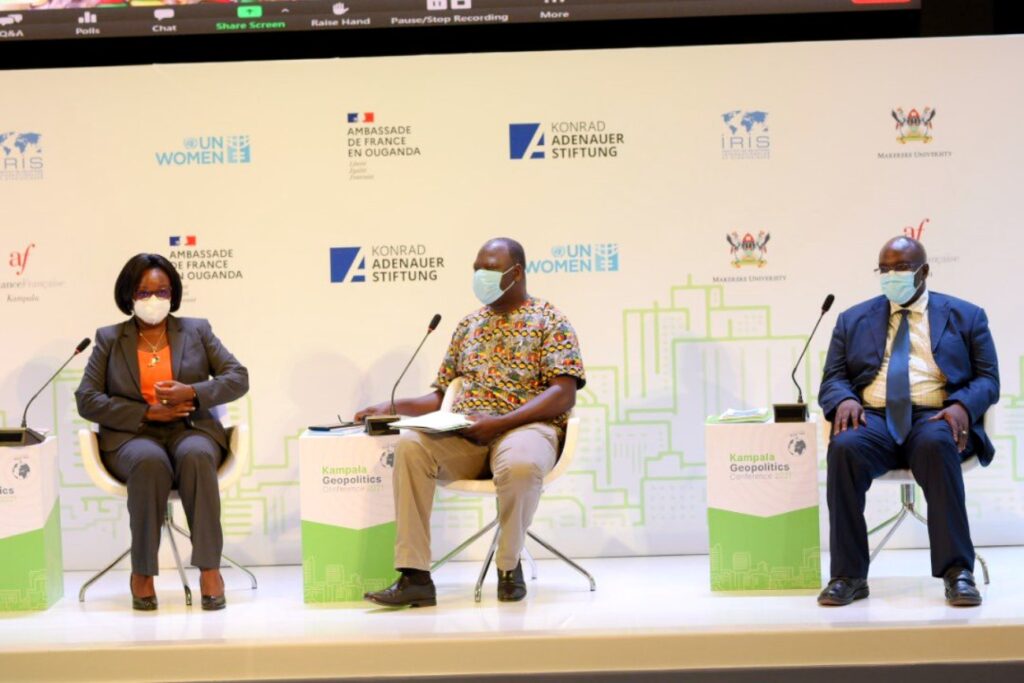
[509,120,626,161]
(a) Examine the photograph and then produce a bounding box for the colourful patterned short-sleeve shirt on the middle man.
[433,297,587,428]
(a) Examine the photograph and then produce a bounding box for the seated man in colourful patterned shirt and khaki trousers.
[355,238,586,606]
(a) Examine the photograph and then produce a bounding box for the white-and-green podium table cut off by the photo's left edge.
[0,436,63,611]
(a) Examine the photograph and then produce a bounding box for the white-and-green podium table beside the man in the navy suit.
[705,418,821,591]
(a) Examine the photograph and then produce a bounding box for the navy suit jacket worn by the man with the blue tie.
[818,292,999,465]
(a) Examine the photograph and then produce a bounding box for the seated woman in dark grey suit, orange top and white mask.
[75,254,249,610]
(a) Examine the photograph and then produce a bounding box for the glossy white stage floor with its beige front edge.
[0,547,1024,681]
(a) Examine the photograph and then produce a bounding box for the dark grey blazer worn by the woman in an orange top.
[75,315,249,452]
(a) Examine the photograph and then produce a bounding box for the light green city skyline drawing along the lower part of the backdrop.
[12,278,1024,563]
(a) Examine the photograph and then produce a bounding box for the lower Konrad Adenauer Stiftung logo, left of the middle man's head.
[330,244,445,285]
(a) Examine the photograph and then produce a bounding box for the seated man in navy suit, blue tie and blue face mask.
[818,237,999,606]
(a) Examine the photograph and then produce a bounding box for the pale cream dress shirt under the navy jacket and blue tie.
[864,289,946,408]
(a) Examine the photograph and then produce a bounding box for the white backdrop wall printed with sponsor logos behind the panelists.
[0,37,1024,568]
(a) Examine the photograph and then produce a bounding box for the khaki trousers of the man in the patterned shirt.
[394,422,559,571]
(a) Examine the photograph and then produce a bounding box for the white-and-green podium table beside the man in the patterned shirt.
[299,430,398,603]
